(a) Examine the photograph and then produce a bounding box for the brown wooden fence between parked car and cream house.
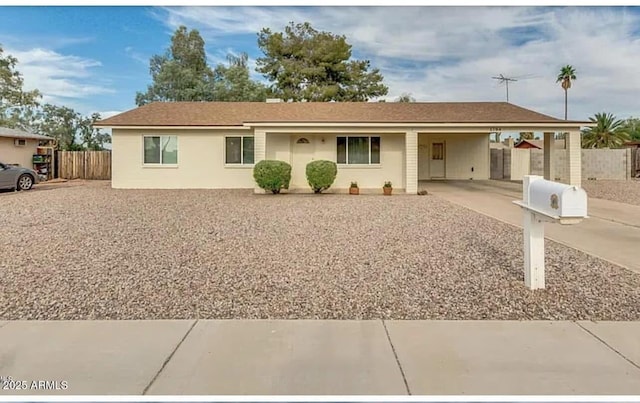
[57,151,111,180]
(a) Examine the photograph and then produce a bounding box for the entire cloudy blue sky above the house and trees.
[0,6,640,119]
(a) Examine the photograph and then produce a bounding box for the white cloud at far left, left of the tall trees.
[6,48,114,103]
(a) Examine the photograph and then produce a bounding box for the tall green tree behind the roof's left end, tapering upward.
[136,26,213,106]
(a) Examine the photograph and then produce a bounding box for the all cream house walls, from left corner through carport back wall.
[112,129,490,190]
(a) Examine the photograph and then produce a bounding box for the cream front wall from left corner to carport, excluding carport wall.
[112,129,405,189]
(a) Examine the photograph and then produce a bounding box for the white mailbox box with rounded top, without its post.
[529,179,587,218]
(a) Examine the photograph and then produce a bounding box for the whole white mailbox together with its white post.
[513,175,588,290]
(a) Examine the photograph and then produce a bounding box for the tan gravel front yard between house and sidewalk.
[0,182,640,320]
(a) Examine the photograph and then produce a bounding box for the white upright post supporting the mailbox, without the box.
[522,175,544,290]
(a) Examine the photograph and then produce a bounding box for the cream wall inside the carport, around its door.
[418,133,491,180]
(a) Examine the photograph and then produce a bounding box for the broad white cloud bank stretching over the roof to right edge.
[163,7,640,119]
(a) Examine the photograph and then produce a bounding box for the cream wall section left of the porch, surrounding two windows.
[111,129,253,189]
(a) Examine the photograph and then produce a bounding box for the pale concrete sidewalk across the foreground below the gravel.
[0,320,640,395]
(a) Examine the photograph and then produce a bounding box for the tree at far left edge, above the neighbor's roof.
[0,46,40,130]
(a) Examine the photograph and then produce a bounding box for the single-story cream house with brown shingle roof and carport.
[95,102,590,193]
